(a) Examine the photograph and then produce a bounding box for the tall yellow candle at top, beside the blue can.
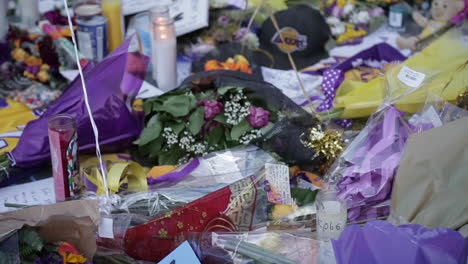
[102,0,123,52]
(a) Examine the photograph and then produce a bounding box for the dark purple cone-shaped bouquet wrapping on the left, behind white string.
[9,38,148,167]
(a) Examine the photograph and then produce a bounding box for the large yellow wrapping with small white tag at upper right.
[335,26,468,118]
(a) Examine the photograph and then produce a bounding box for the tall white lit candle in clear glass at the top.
[151,7,177,91]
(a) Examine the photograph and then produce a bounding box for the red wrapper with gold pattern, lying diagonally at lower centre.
[125,165,278,261]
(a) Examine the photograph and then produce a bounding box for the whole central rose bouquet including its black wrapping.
[136,71,318,165]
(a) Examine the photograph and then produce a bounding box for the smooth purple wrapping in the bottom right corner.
[332,221,468,264]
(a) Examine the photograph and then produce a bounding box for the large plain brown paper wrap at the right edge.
[391,117,468,229]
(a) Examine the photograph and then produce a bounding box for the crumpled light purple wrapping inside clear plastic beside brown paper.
[338,106,414,221]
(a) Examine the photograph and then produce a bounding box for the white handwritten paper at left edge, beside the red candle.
[0,178,55,213]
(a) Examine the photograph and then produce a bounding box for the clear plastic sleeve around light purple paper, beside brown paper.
[326,78,465,222]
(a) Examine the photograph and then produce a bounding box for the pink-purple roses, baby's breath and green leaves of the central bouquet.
[137,78,279,165]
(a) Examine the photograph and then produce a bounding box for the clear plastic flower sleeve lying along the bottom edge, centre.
[189,230,318,264]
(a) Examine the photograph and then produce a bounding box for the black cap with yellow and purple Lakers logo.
[260,5,331,70]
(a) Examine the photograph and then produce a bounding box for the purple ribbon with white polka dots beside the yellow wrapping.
[317,43,406,128]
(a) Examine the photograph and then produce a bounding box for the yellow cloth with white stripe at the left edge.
[0,99,37,154]
